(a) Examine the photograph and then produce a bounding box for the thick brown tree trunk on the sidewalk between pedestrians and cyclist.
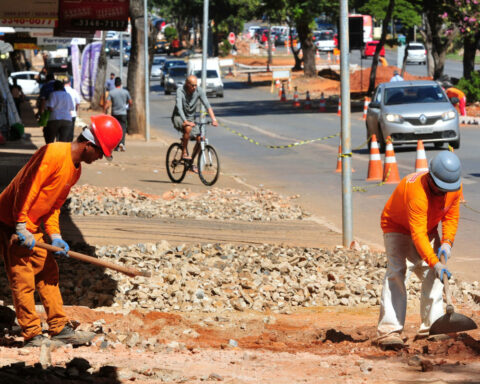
[127,0,146,136]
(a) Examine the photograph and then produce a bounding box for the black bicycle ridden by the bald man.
[166,121,220,186]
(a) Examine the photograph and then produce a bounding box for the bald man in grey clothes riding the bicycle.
[172,75,218,160]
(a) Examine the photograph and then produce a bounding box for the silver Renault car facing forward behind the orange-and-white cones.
[366,80,460,152]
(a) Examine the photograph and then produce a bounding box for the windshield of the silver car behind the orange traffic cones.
[385,85,447,105]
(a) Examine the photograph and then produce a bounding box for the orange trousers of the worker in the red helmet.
[0,227,68,340]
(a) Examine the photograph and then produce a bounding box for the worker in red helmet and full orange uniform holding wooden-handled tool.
[0,115,122,347]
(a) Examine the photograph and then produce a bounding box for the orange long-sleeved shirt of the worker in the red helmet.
[0,142,81,235]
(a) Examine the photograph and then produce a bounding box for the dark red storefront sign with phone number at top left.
[59,0,129,31]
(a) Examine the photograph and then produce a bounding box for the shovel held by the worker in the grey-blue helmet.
[430,254,478,335]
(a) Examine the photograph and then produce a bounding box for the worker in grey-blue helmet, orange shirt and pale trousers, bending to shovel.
[376,151,462,348]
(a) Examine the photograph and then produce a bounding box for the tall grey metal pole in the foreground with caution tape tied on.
[340,0,353,247]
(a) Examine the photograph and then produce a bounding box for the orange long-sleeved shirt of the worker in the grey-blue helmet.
[381,172,462,267]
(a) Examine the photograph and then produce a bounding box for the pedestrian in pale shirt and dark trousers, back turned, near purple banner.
[43,80,75,144]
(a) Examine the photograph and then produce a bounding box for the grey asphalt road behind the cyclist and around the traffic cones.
[109,57,480,280]
